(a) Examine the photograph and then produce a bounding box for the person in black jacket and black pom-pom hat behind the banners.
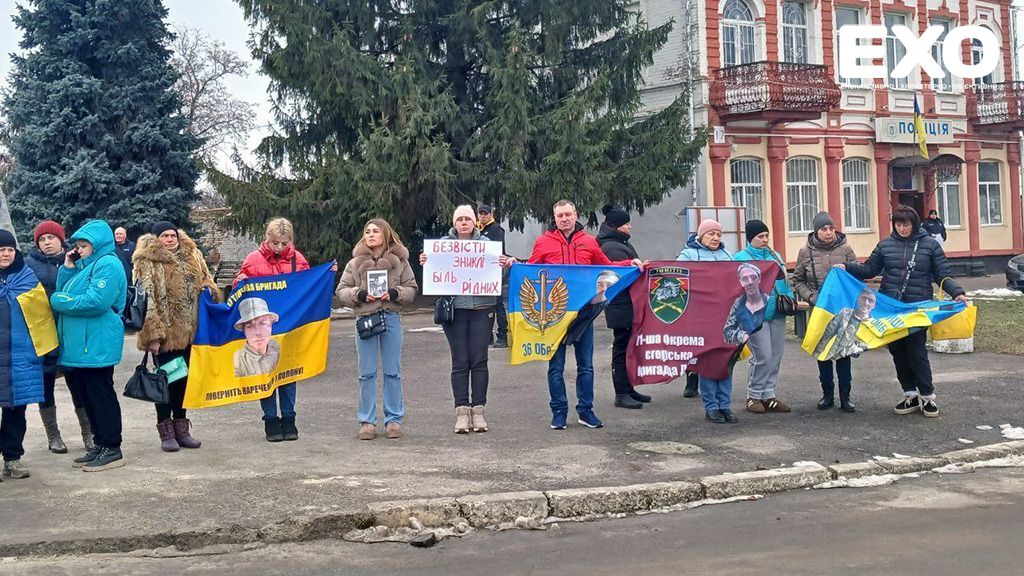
[597,204,650,408]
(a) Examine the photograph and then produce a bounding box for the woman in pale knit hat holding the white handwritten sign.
[420,204,514,434]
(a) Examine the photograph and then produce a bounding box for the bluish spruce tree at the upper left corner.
[4,0,198,236]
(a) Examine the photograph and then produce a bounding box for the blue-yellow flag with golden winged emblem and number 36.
[507,263,641,364]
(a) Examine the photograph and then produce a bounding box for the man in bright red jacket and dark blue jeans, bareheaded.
[527,200,643,430]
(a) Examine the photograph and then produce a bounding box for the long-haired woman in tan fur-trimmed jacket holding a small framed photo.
[335,218,415,440]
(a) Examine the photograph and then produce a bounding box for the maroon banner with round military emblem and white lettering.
[626,260,782,385]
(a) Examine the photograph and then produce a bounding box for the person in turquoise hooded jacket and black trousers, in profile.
[50,220,128,471]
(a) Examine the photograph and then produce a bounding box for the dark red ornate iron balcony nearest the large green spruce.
[709,61,842,122]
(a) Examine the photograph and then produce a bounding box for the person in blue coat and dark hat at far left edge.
[0,230,52,480]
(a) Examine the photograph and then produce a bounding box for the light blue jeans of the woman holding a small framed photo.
[355,312,406,425]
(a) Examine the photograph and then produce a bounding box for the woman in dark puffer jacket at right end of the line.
[840,206,967,417]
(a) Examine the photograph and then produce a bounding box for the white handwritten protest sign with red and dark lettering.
[423,240,502,296]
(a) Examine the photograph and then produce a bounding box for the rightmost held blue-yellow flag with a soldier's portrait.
[802,269,967,360]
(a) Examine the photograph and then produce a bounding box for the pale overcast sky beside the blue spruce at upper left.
[0,0,270,168]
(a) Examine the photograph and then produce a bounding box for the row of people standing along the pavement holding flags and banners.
[0,200,965,480]
